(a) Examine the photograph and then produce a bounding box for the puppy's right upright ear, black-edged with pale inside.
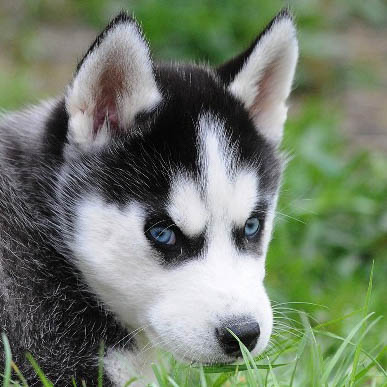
[218,10,298,145]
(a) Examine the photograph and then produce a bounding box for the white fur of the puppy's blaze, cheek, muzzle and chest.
[71,114,272,385]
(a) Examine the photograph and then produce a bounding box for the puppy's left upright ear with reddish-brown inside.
[66,13,161,150]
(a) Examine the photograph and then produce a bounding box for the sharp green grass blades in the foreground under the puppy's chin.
[2,269,387,387]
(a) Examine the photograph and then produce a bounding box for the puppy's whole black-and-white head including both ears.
[57,12,297,363]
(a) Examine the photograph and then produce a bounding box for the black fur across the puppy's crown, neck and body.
[0,13,281,386]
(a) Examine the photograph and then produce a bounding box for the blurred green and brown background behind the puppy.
[0,0,387,366]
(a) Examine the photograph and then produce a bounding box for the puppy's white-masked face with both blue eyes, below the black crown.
[71,110,280,362]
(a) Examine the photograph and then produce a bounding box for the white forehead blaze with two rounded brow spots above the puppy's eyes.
[168,112,259,235]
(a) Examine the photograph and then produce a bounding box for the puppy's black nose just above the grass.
[215,318,261,357]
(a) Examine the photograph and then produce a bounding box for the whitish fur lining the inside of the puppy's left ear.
[66,22,161,150]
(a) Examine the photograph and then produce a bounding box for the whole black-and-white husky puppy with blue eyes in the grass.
[0,10,298,386]
